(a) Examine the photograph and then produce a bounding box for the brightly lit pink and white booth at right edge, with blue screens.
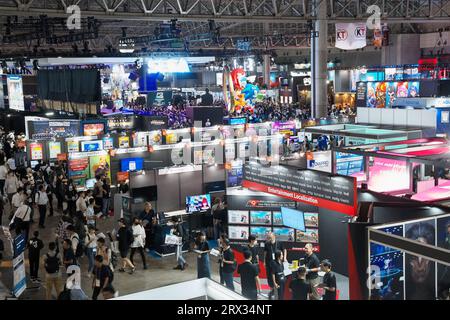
[335,138,450,202]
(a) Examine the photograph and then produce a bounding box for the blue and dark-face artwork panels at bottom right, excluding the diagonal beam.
[369,215,450,300]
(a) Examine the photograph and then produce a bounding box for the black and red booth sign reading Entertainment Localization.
[242,162,357,215]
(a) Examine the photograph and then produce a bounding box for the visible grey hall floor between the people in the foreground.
[0,202,348,300]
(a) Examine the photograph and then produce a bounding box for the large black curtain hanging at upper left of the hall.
[38,69,101,103]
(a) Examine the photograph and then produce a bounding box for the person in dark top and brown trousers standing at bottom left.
[44,242,62,300]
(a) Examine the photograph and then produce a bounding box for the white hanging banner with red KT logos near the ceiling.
[336,22,367,50]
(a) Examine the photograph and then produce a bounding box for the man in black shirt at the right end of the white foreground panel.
[238,250,260,300]
